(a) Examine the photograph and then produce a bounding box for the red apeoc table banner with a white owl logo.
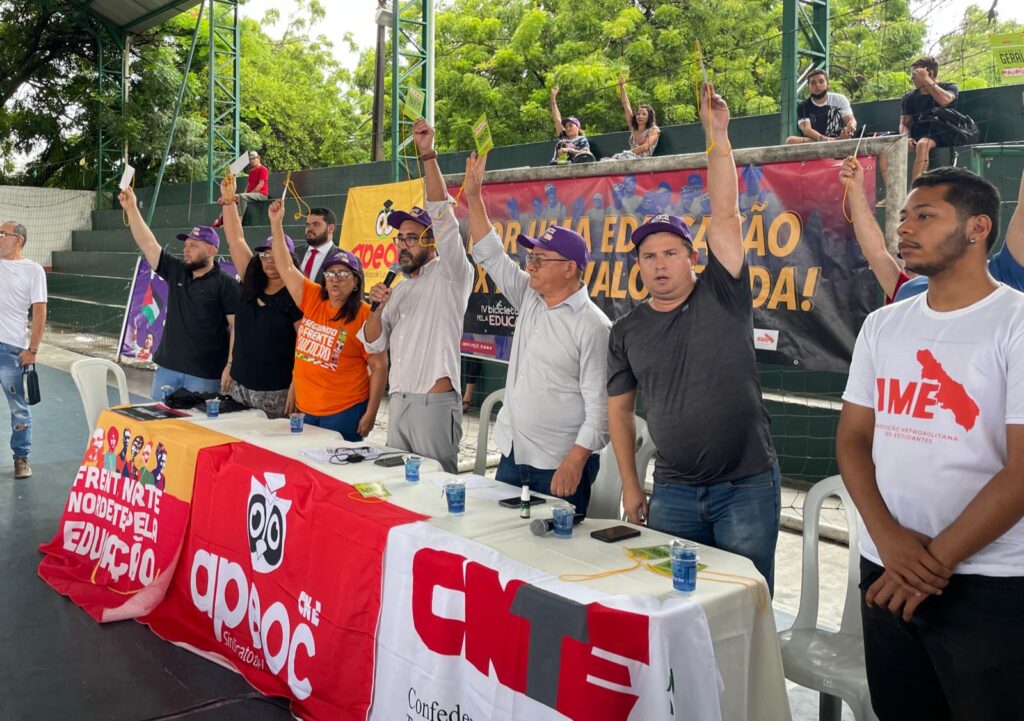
[141,443,424,721]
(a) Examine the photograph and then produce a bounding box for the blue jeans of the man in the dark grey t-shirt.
[647,463,782,594]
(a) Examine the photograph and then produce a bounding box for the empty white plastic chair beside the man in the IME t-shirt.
[778,475,878,721]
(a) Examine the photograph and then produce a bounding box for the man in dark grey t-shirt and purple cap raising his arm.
[608,88,780,592]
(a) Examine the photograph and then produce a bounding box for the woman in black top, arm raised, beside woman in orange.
[220,177,302,418]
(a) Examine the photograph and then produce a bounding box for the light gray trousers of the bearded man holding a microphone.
[387,390,462,473]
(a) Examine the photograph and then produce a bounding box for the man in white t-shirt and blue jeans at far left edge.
[0,220,46,478]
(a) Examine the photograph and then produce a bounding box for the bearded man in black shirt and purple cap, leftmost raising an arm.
[120,187,241,398]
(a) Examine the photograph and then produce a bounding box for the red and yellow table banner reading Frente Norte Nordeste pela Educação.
[39,411,234,622]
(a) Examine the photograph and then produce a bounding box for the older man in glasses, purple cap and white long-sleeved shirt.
[465,151,611,513]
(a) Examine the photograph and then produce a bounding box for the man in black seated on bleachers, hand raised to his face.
[899,57,957,181]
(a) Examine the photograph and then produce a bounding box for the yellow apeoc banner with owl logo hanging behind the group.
[341,180,423,290]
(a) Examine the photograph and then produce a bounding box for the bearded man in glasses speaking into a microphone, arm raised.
[358,119,474,473]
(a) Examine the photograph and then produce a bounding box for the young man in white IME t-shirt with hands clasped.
[837,168,1024,721]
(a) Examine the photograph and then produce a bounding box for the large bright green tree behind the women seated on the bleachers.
[354,0,926,150]
